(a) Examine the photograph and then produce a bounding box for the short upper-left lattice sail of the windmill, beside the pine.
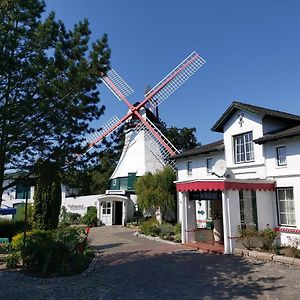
[102,69,134,100]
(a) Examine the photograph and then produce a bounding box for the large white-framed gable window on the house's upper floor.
[234,132,254,164]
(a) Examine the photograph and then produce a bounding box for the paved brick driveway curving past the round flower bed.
[0,227,300,300]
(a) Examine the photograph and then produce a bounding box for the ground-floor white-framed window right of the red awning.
[276,187,296,226]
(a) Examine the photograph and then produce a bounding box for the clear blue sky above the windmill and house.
[46,0,300,144]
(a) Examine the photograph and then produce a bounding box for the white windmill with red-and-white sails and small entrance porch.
[88,52,205,225]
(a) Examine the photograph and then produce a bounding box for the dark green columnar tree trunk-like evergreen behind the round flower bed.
[33,160,61,230]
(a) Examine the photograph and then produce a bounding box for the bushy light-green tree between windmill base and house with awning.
[135,166,176,221]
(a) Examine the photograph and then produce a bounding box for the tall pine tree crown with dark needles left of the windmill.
[0,0,110,204]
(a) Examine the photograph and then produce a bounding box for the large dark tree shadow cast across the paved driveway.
[100,250,285,299]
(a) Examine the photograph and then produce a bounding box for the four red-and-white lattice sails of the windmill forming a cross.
[84,52,205,156]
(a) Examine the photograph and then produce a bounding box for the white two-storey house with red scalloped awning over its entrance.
[175,102,300,253]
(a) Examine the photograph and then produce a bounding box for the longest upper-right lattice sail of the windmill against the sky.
[145,52,205,107]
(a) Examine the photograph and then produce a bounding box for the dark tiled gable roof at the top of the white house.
[211,101,300,132]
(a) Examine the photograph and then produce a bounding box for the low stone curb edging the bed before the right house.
[233,248,300,267]
